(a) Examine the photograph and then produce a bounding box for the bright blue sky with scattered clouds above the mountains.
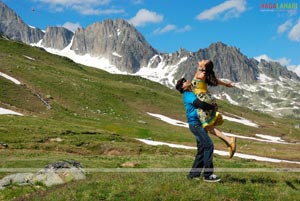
[2,0,300,76]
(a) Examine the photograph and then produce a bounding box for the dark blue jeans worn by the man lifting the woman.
[189,123,214,178]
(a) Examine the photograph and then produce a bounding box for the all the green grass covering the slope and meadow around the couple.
[0,39,300,200]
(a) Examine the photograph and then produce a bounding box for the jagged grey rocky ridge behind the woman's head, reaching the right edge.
[169,42,300,83]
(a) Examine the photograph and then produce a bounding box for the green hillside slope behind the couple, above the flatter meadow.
[0,35,299,148]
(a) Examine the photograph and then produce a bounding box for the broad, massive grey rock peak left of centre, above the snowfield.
[71,19,157,73]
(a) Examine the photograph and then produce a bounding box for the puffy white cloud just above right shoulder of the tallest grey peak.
[128,9,164,26]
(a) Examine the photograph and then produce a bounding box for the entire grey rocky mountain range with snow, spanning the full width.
[0,3,300,116]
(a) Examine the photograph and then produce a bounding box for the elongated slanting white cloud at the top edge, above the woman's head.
[196,0,246,20]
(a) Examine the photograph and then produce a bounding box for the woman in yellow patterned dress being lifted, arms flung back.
[192,60,236,158]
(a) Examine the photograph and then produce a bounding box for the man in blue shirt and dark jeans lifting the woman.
[176,78,221,182]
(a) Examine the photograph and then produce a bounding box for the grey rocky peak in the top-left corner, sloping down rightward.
[0,1,44,44]
